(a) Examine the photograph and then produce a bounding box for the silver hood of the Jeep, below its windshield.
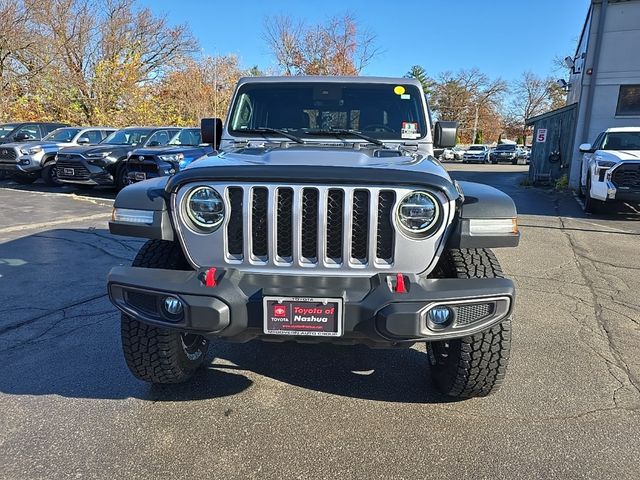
[187,145,449,179]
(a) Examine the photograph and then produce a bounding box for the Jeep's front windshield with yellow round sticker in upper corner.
[229,82,427,140]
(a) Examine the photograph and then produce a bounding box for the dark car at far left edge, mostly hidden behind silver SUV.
[0,122,68,179]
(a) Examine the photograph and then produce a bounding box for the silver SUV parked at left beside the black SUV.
[1,127,115,185]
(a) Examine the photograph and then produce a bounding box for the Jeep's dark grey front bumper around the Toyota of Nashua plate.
[108,267,515,347]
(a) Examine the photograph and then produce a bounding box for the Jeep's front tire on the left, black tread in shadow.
[121,240,209,383]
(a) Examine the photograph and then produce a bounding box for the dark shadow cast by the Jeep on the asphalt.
[0,228,456,403]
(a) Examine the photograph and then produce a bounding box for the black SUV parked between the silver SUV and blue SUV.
[56,127,180,190]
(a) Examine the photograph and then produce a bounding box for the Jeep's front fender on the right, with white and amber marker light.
[447,182,520,248]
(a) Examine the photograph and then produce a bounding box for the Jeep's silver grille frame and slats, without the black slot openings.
[171,182,455,276]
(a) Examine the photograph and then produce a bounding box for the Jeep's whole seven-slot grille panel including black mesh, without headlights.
[172,181,454,276]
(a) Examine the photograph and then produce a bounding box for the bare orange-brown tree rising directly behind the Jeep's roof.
[264,14,379,75]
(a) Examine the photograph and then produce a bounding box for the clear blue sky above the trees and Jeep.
[140,0,590,81]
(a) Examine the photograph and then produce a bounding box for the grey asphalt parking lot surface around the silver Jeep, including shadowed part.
[0,164,640,479]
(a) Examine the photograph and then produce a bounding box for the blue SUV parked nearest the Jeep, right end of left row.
[125,128,213,183]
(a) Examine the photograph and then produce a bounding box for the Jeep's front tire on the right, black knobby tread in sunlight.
[427,248,511,398]
